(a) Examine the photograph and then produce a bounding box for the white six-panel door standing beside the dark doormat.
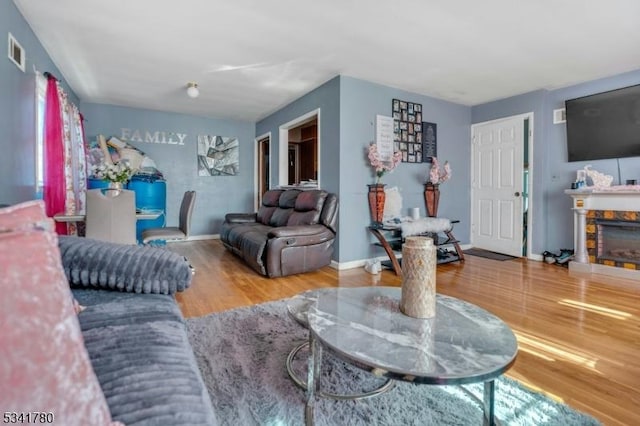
[471,116,525,257]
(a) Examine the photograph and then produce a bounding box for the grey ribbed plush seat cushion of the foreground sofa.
[73,289,217,426]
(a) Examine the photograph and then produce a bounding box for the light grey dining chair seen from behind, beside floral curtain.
[85,188,137,244]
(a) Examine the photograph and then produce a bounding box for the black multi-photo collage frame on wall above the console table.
[391,99,431,163]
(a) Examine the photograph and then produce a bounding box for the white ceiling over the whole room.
[14,0,640,121]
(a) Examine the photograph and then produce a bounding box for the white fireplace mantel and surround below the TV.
[564,185,640,279]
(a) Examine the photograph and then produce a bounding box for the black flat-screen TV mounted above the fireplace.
[565,84,640,161]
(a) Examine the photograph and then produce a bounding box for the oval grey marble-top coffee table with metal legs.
[305,287,518,425]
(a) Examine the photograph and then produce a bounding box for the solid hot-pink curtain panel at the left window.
[43,74,67,235]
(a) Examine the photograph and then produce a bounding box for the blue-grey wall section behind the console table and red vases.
[339,77,471,262]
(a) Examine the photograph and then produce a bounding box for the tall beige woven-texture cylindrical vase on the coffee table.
[400,237,437,318]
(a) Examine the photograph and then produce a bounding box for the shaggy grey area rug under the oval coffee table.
[187,300,599,426]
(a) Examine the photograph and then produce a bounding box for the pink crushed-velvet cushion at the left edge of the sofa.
[0,202,119,425]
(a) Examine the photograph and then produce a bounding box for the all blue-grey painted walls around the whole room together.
[6,1,640,262]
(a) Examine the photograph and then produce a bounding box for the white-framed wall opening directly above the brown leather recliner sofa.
[279,109,320,188]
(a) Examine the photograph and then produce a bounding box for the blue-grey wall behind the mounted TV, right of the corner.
[472,70,640,254]
